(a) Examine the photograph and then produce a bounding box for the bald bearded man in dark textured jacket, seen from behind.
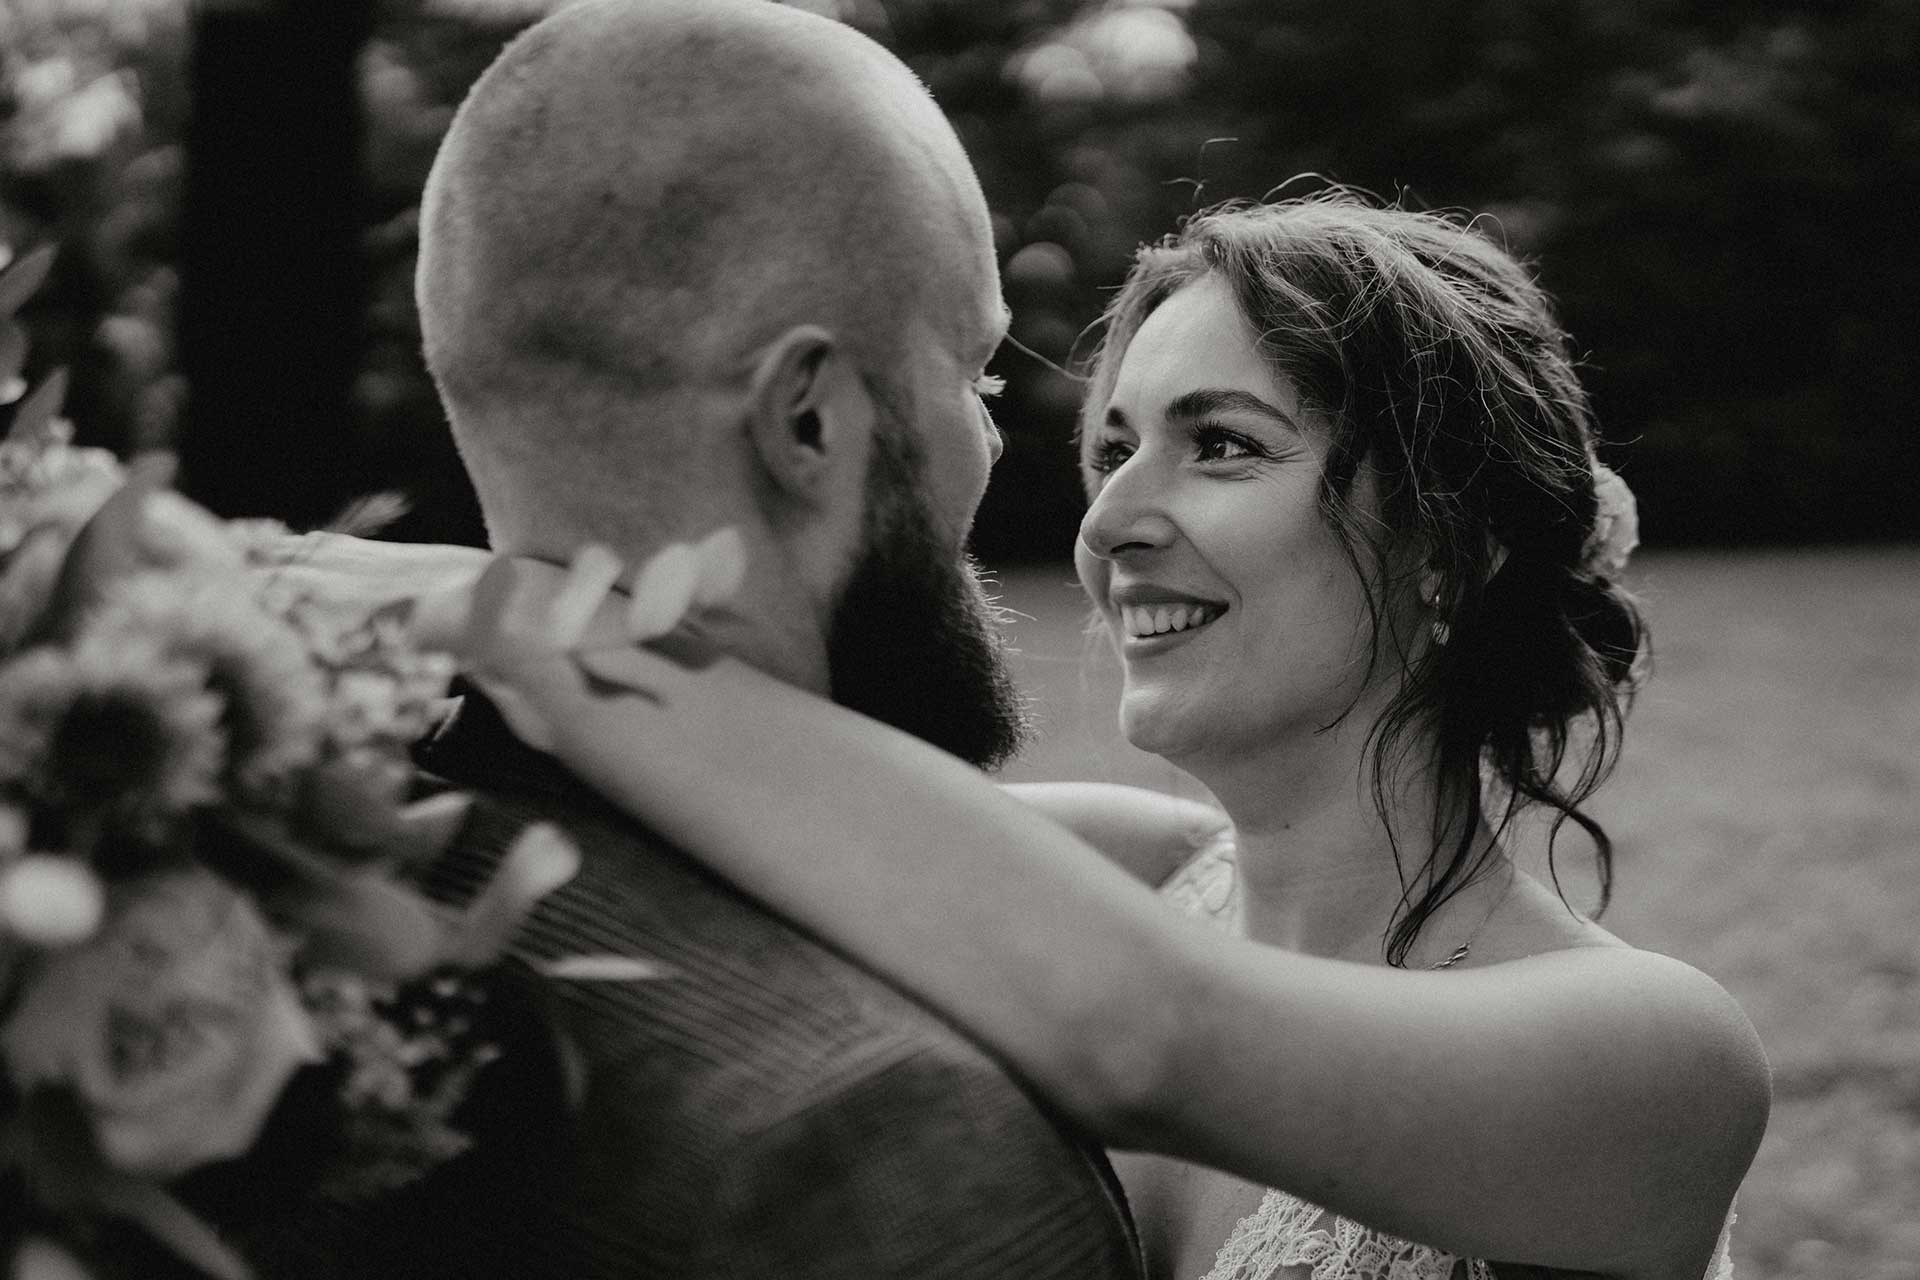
[270,0,1140,1280]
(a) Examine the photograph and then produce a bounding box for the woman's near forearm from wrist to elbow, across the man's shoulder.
[538,660,1208,1142]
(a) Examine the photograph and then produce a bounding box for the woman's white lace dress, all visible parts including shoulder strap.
[1162,837,1734,1280]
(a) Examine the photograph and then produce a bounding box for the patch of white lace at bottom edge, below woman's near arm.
[1206,1192,1494,1280]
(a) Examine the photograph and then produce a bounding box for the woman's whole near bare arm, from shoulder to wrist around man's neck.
[456,556,1766,1280]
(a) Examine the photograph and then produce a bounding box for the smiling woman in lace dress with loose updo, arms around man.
[453,198,1768,1280]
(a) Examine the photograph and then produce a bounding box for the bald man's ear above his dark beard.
[747,324,876,503]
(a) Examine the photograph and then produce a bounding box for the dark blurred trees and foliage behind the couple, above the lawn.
[0,0,1920,560]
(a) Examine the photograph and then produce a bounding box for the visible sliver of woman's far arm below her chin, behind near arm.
[1000,783,1233,885]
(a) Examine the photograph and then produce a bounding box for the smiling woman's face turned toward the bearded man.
[1075,274,1371,760]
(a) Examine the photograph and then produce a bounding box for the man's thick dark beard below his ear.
[828,422,1027,770]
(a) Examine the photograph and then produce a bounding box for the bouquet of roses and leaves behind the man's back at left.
[0,245,595,1280]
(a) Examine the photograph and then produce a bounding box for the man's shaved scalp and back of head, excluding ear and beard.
[419,0,993,553]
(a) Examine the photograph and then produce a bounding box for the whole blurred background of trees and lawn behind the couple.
[0,0,1920,1280]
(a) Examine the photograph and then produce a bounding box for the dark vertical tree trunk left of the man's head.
[175,0,372,524]
